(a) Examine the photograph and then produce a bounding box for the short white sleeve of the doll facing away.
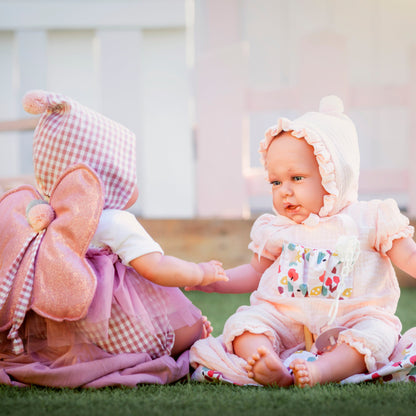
[91,209,163,265]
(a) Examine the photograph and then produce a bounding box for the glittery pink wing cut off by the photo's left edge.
[0,185,41,330]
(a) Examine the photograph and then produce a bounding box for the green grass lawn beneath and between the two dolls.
[0,289,416,416]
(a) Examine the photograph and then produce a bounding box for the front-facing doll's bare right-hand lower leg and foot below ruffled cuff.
[290,344,366,387]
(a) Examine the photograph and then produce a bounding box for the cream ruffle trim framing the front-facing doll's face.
[259,117,339,217]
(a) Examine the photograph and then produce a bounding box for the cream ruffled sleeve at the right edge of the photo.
[374,199,414,255]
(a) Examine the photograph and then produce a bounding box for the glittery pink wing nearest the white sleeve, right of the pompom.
[32,164,104,321]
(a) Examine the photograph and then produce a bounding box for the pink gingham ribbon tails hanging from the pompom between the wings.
[0,230,45,354]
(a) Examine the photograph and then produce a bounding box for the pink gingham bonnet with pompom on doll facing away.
[23,90,137,209]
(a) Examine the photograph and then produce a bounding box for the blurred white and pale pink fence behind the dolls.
[0,0,416,221]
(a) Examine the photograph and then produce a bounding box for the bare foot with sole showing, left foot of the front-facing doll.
[246,347,293,387]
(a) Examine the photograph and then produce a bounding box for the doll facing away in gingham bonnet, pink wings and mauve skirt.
[0,90,228,387]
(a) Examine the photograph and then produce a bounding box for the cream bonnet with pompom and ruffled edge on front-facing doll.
[259,95,360,217]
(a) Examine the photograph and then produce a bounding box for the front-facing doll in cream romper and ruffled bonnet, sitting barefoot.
[191,96,416,387]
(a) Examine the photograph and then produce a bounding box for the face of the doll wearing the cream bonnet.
[266,132,327,224]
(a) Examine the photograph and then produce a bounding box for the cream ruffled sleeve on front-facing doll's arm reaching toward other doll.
[248,214,283,261]
